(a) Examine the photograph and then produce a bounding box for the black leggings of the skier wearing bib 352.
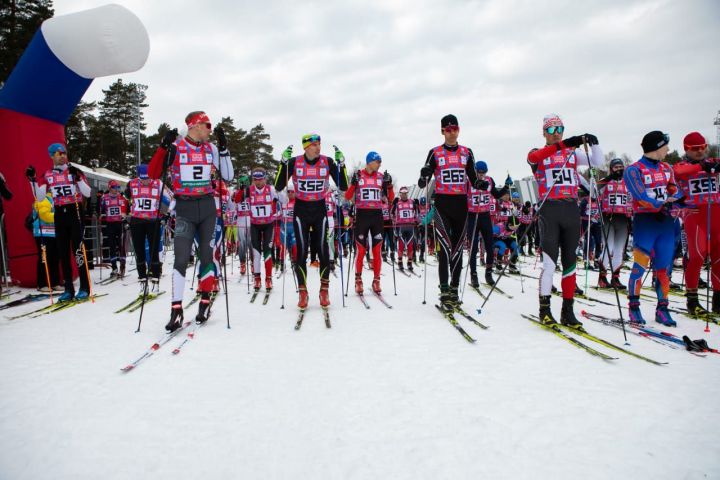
[293,200,330,285]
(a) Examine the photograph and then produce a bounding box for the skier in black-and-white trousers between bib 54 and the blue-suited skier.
[598,158,631,290]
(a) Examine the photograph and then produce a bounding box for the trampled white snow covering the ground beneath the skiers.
[0,253,720,480]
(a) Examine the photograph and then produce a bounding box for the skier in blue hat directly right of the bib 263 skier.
[467,160,512,288]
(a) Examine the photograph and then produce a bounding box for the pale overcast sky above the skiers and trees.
[55,0,720,184]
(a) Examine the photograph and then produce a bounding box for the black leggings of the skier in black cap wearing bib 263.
[434,195,468,287]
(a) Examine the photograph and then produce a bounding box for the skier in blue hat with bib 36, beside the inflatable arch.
[25,143,91,302]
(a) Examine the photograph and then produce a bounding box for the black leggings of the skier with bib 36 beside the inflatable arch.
[55,204,90,293]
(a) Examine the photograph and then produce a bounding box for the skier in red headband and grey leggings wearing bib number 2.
[148,111,233,332]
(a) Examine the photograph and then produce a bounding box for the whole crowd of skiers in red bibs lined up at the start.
[21,111,720,331]
